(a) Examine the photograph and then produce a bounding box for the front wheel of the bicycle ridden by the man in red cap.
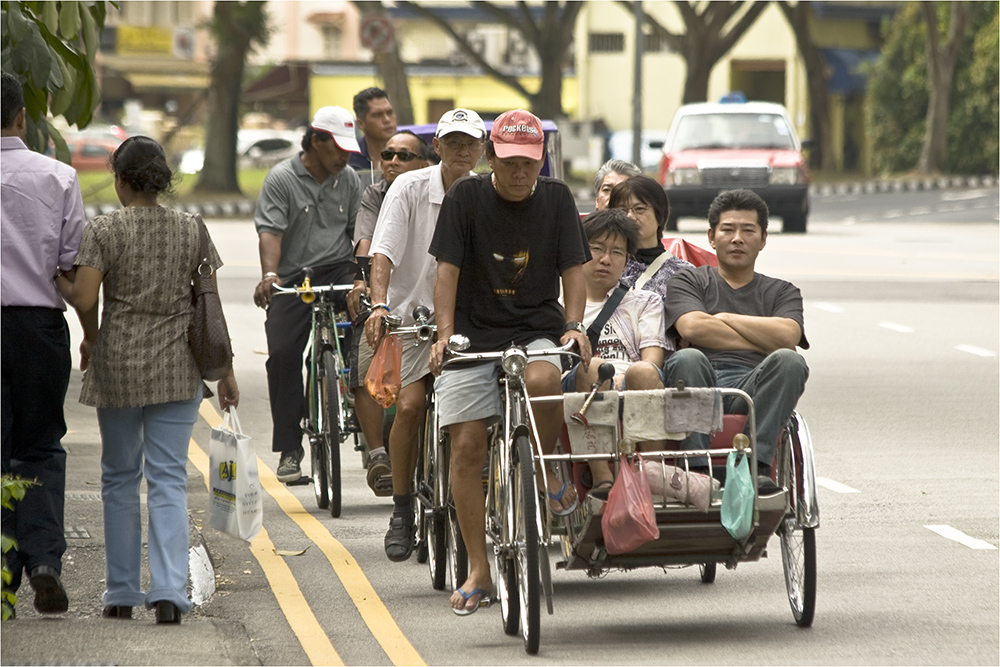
[513,435,541,655]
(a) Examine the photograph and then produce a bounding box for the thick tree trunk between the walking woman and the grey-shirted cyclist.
[195,0,271,193]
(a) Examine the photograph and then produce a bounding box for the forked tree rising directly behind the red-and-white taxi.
[621,0,768,104]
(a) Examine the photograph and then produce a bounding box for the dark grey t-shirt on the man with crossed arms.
[664,266,809,367]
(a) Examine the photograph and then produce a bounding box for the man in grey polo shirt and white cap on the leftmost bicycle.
[253,107,361,482]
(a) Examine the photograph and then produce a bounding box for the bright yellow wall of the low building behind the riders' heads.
[309,74,579,124]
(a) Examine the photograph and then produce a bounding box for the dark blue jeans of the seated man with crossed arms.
[667,348,809,466]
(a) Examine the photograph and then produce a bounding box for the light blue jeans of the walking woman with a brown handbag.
[97,384,202,613]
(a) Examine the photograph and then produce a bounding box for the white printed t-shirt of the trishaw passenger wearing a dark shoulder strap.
[583,290,670,376]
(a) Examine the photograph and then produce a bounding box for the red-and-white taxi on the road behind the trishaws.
[659,96,810,232]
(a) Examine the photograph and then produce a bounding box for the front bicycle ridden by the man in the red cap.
[443,335,579,654]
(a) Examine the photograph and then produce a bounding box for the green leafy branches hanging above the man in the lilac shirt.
[0,0,118,163]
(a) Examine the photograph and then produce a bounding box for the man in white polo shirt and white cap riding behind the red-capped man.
[359,109,486,561]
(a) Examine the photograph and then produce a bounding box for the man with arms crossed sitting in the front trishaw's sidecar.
[666,190,809,494]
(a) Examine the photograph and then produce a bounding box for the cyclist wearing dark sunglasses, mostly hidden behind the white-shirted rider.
[347,130,431,496]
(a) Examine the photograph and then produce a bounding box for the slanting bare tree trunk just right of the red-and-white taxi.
[777,0,837,171]
